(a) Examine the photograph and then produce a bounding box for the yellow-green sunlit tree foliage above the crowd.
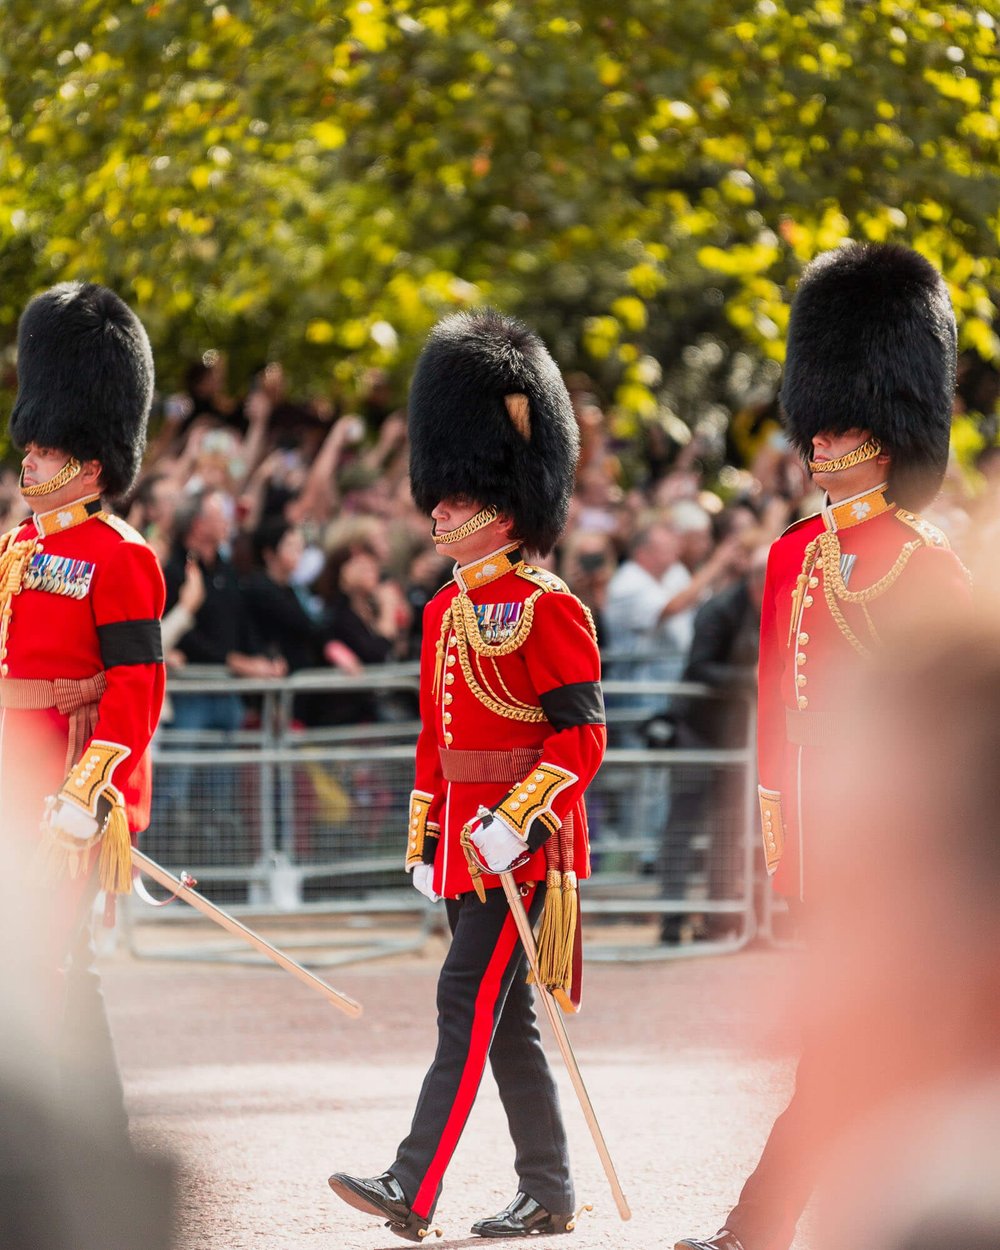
[0,0,1000,432]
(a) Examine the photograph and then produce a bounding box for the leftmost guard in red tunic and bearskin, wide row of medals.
[0,283,164,1136]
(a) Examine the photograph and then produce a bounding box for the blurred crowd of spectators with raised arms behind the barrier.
[0,351,1000,745]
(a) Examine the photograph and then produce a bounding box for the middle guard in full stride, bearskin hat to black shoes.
[330,311,605,1240]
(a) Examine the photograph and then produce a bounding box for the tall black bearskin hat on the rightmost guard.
[781,243,955,509]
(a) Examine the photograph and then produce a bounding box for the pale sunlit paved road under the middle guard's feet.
[104,925,808,1250]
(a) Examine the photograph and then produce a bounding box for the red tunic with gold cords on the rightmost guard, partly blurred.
[758,489,970,898]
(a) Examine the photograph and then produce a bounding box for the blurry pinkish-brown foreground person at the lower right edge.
[806,616,1000,1250]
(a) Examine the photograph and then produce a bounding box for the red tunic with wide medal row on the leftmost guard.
[0,501,164,838]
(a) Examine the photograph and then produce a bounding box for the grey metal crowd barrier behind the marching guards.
[123,665,769,965]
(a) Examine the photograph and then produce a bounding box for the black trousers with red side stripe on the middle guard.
[389,884,574,1219]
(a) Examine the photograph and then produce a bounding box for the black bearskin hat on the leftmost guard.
[10,283,153,499]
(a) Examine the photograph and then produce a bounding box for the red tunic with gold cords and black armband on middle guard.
[406,548,606,898]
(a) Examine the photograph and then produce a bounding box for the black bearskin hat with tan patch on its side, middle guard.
[409,309,580,555]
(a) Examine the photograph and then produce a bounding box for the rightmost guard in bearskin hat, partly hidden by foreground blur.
[676,244,970,1250]
